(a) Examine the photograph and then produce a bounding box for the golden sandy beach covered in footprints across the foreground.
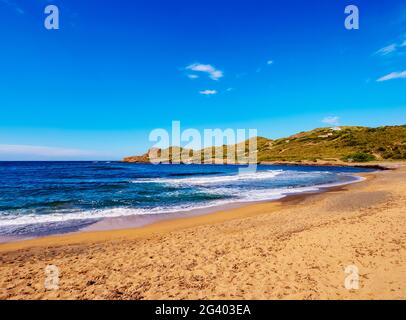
[0,167,406,299]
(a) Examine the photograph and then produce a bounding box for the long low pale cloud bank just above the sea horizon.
[0,144,96,157]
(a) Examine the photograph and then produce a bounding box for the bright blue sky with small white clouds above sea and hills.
[0,0,406,160]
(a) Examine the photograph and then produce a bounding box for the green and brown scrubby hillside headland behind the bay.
[124,125,406,162]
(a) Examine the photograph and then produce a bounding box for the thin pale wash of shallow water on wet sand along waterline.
[0,172,366,248]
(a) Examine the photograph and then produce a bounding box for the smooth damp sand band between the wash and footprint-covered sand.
[0,167,374,253]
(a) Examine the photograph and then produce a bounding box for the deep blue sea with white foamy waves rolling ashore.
[0,162,370,236]
